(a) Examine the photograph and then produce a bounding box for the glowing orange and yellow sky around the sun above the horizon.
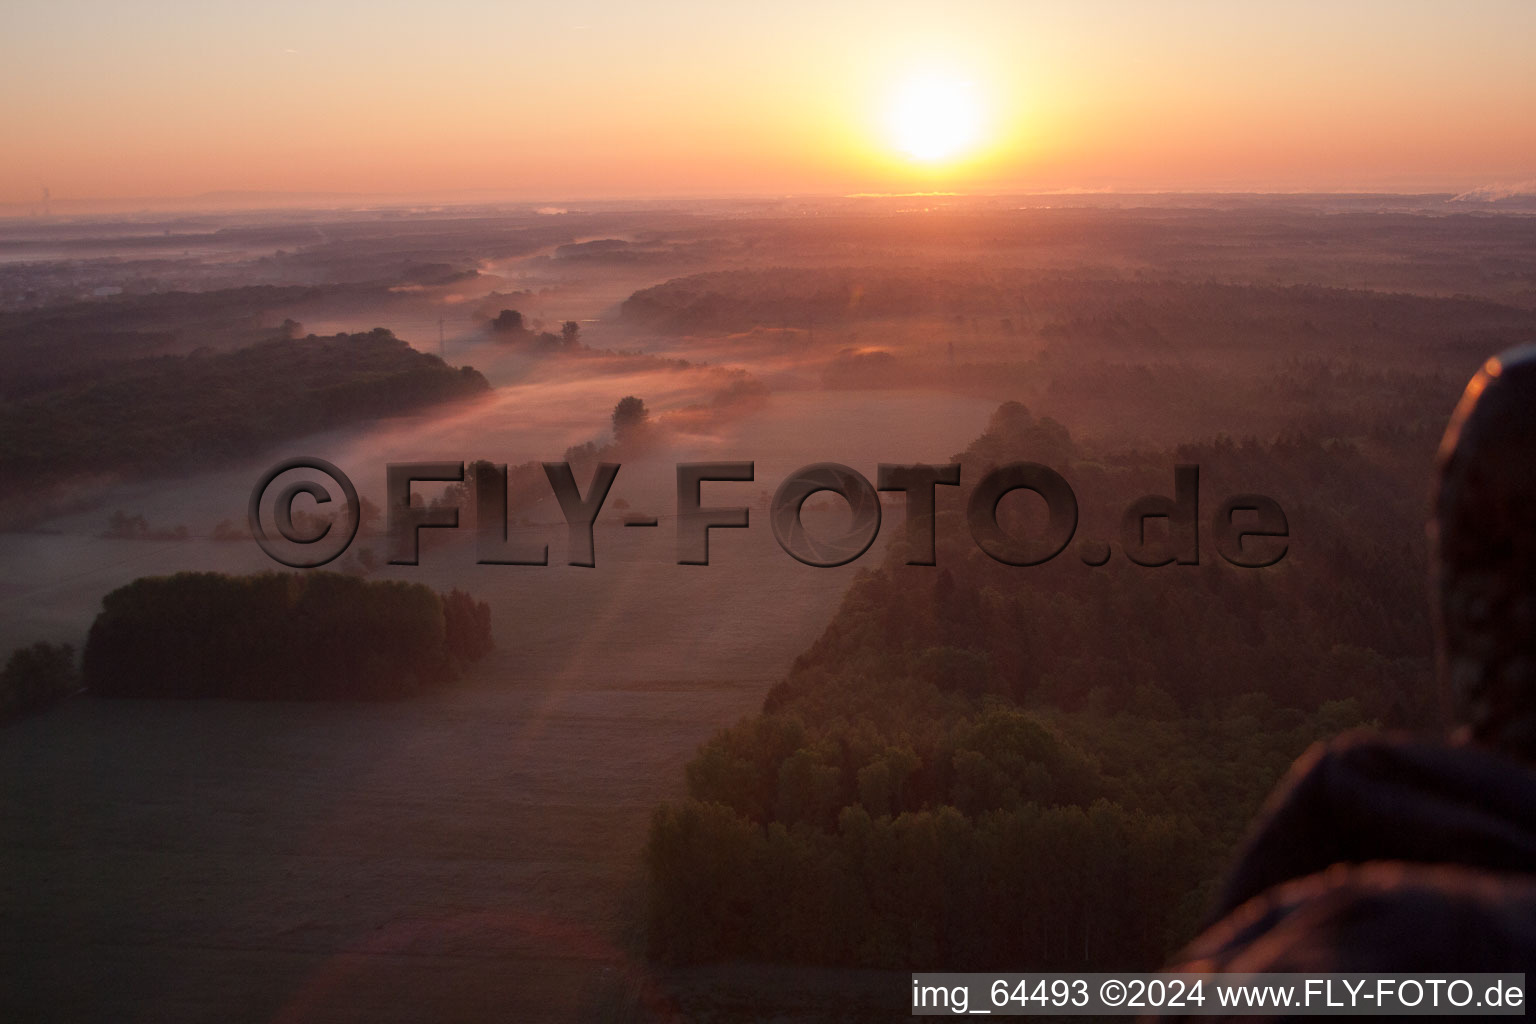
[0,0,1536,203]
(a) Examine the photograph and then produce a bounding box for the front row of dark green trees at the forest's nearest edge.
[647,800,1197,970]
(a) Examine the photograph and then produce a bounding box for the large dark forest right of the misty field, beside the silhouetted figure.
[647,399,1435,970]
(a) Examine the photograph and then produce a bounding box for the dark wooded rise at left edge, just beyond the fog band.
[0,329,490,512]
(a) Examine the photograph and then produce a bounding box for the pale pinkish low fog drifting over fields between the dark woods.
[0,224,994,679]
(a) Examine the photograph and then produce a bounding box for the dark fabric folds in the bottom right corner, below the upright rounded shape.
[1161,735,1536,1021]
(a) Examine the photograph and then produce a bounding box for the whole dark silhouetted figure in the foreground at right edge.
[1174,347,1536,994]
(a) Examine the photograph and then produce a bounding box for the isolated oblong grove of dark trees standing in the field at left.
[81,573,492,700]
